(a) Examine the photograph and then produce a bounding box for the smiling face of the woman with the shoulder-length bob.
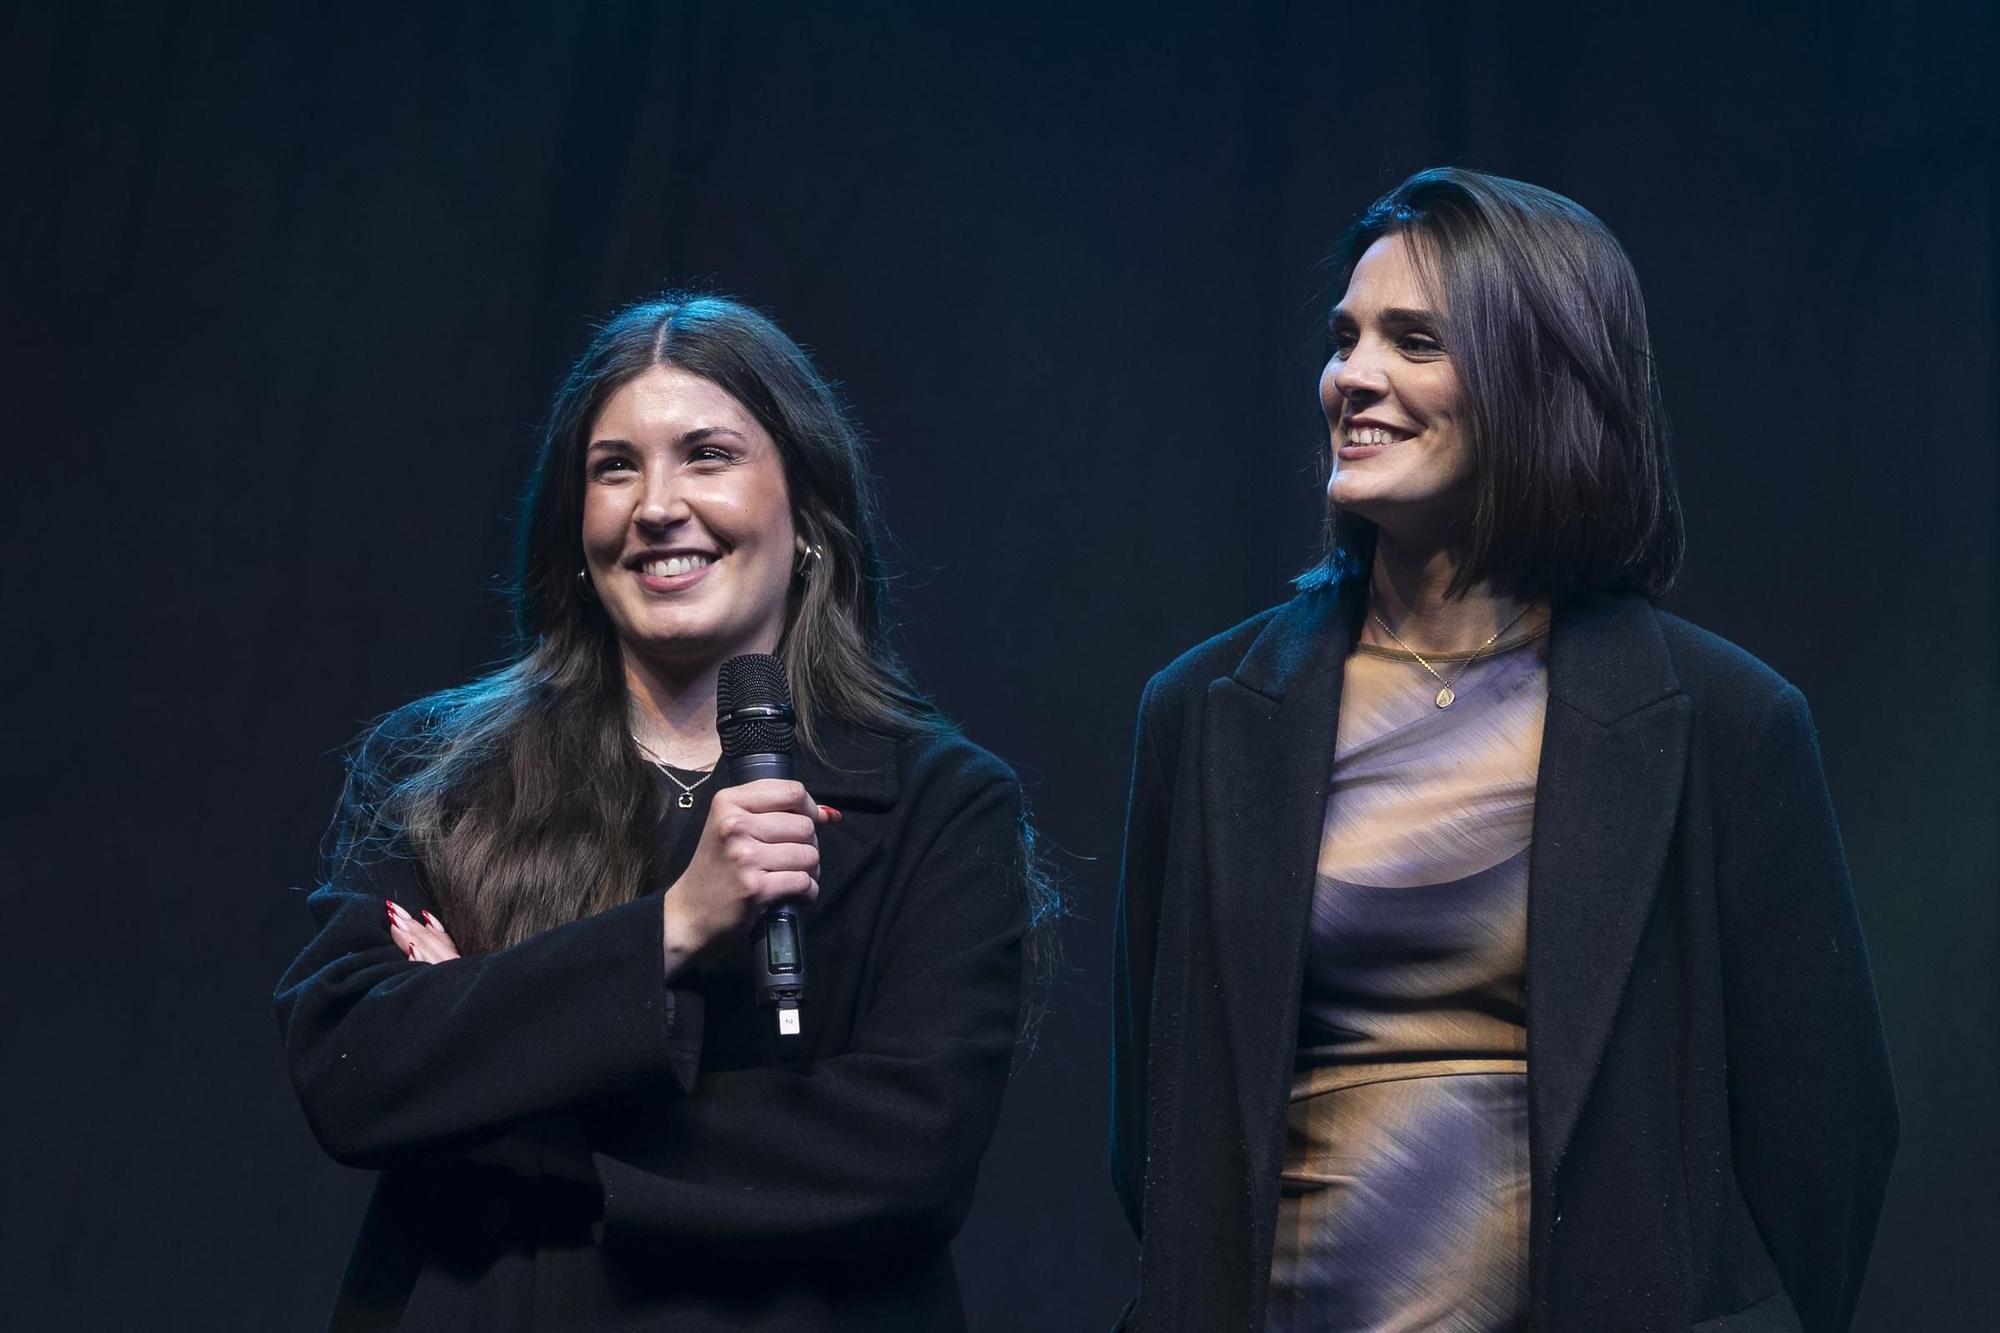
[1320,232,1472,542]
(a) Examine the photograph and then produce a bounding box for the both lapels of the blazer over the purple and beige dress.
[1200,584,1690,1272]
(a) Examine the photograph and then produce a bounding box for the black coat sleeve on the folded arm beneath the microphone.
[594,777,1026,1253]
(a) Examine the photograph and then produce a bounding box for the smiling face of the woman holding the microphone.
[584,366,796,677]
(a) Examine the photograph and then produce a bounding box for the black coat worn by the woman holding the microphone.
[278,727,1026,1333]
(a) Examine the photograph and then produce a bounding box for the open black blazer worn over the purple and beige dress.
[1112,590,1896,1333]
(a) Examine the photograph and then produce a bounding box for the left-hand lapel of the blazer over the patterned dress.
[1202,592,1352,1224]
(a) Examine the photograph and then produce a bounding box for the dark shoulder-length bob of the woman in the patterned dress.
[1296,166,1684,602]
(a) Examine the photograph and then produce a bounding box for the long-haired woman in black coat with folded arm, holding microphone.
[278,296,1042,1331]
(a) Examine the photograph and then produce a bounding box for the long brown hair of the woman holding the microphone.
[334,292,950,953]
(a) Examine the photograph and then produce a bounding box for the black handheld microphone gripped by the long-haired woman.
[716,652,806,1037]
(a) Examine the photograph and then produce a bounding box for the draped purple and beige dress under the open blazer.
[1266,634,1548,1333]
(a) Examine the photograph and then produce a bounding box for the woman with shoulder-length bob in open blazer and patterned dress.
[1112,168,1896,1333]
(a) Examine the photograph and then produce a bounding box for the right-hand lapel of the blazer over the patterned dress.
[1528,596,1690,1176]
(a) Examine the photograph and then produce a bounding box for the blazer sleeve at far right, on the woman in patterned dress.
[1718,687,1898,1333]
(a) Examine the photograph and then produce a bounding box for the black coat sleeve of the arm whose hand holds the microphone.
[276,756,702,1177]
